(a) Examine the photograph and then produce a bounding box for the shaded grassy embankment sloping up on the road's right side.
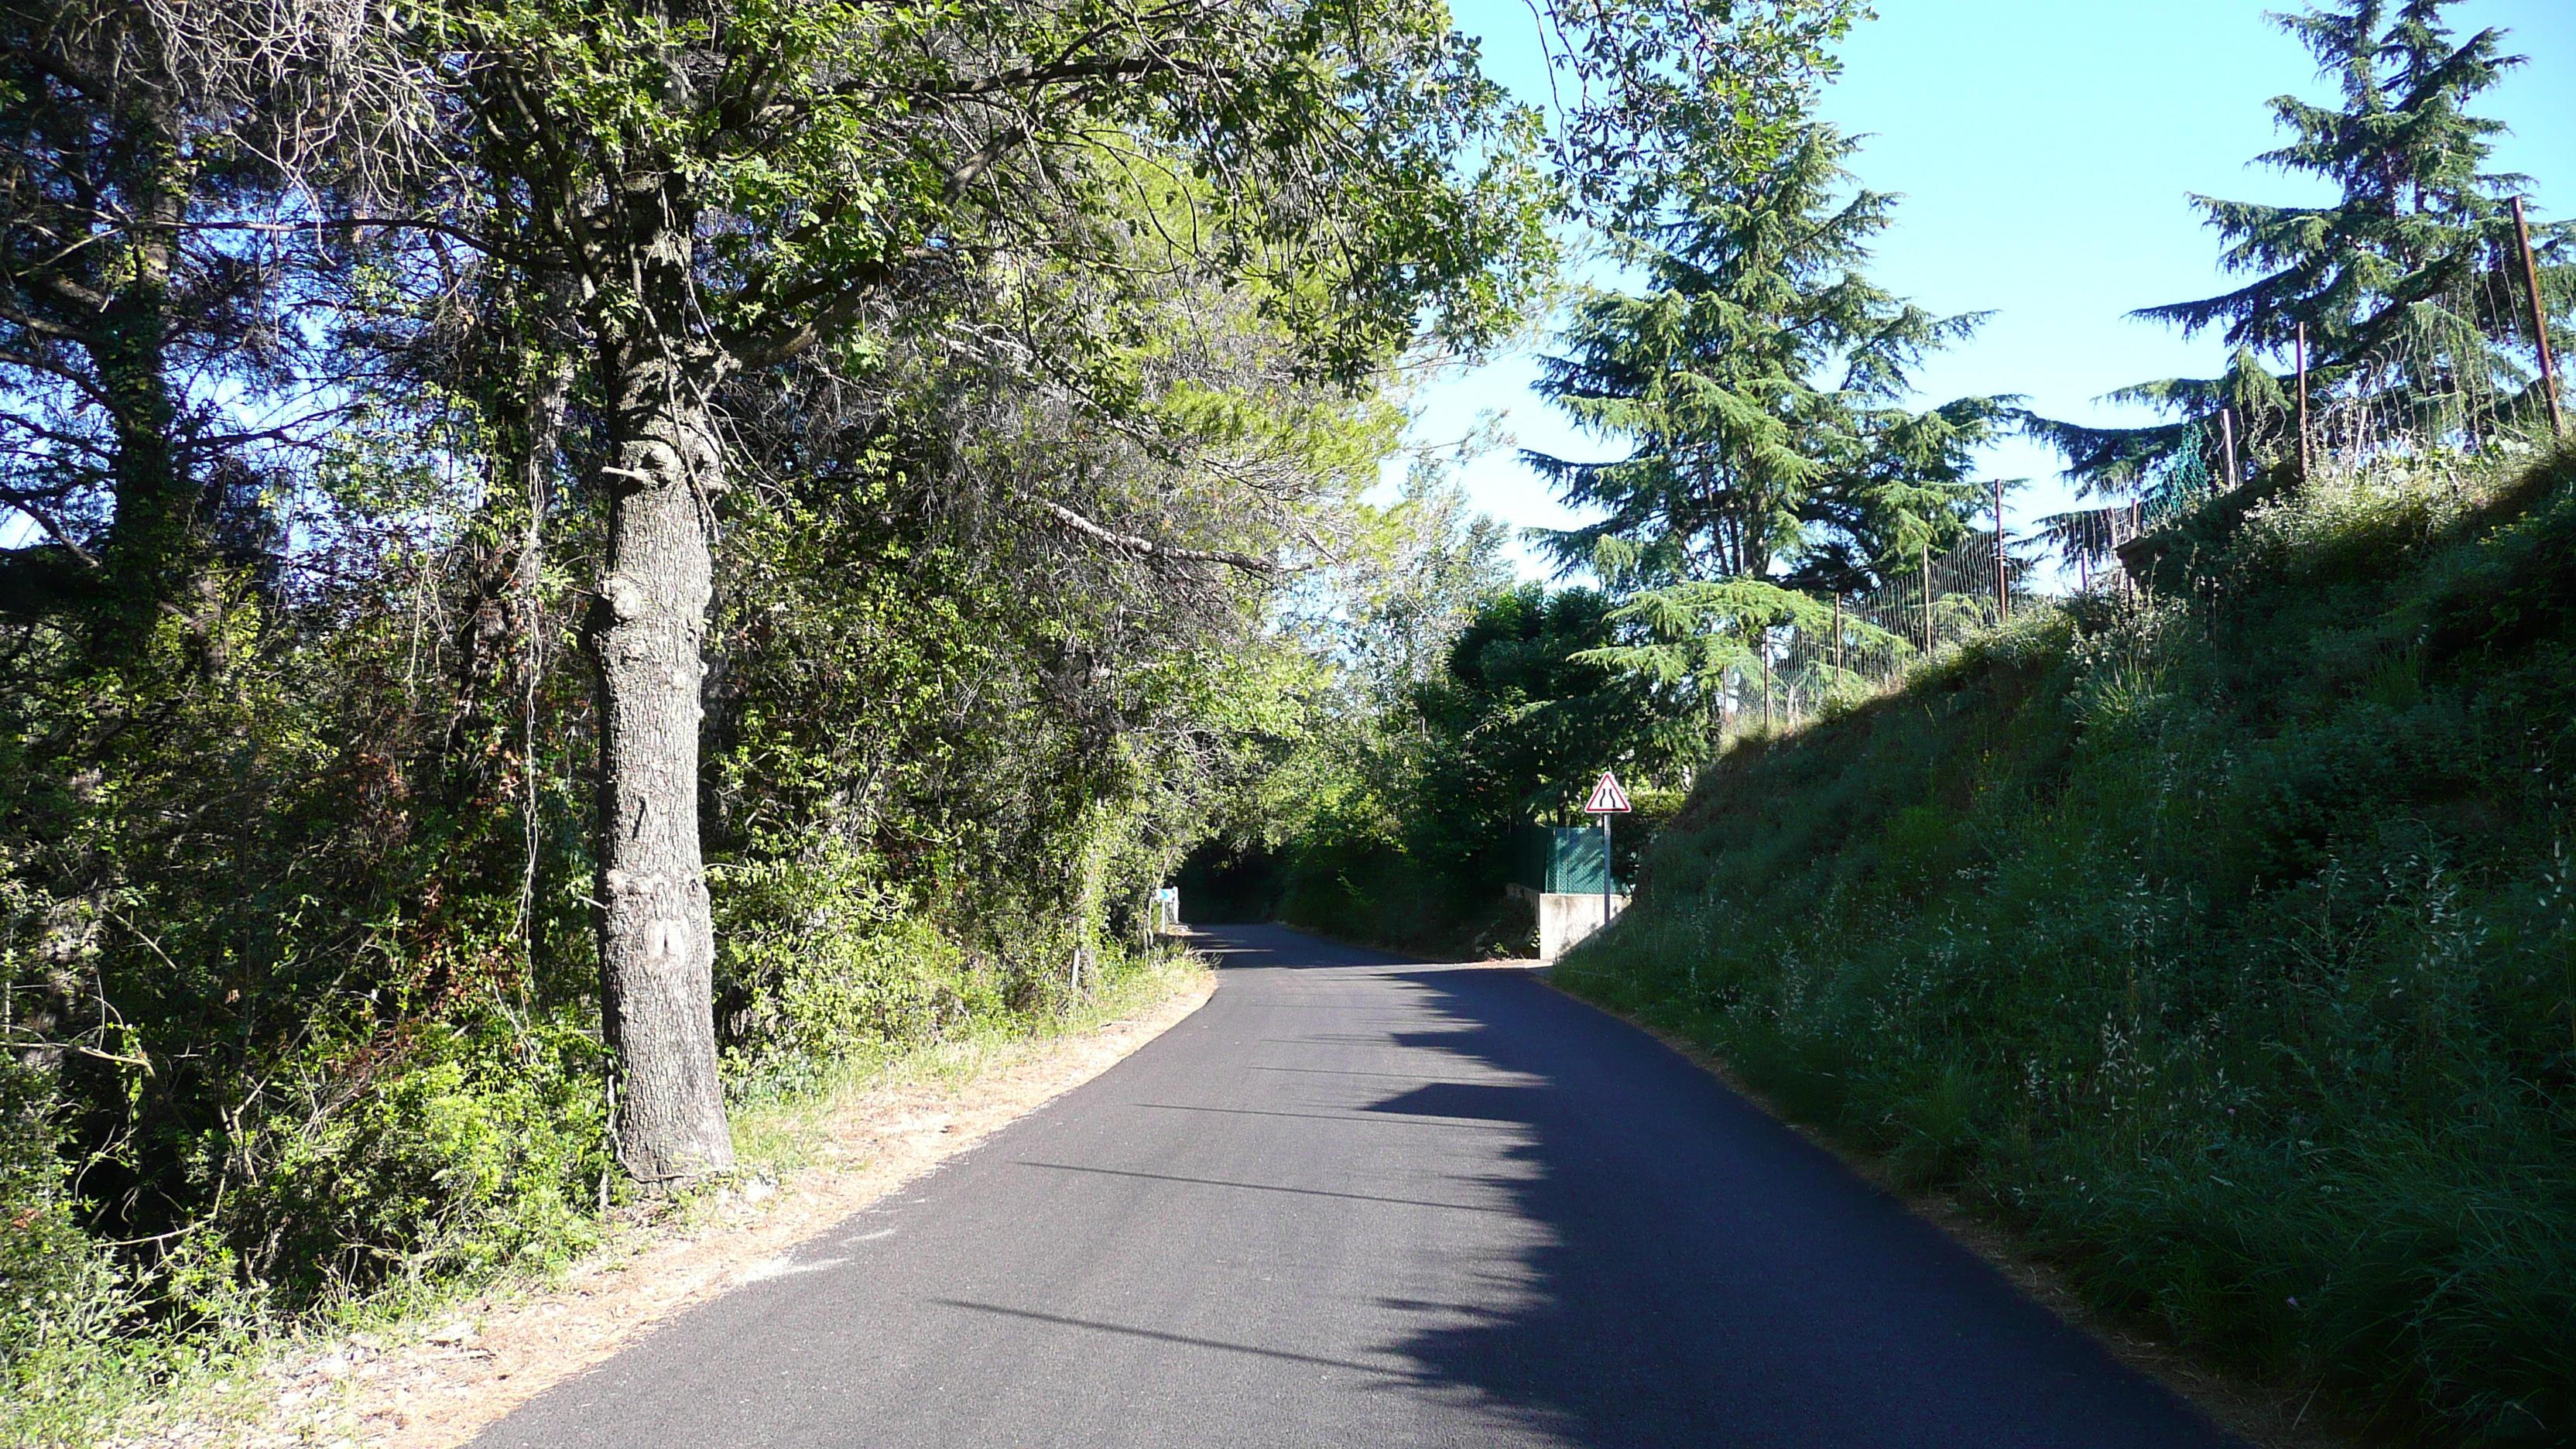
[1556,449,2576,1444]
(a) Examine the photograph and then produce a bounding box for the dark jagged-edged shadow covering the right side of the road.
[1349,961,2233,1449]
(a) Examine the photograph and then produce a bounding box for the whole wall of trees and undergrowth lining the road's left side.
[0,0,1896,1413]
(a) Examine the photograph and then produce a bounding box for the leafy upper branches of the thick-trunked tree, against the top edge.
[433,0,1553,384]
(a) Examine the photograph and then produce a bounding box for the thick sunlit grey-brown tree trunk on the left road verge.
[587,313,734,1186]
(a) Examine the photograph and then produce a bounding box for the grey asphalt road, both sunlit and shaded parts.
[479,926,2233,1449]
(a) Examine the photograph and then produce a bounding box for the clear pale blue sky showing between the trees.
[1414,0,2576,575]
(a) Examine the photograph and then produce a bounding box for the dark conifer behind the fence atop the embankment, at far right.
[2035,0,2576,492]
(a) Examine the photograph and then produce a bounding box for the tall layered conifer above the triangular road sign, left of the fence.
[1525,124,2014,585]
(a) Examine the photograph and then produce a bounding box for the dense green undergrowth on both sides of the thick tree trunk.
[0,464,1249,1441]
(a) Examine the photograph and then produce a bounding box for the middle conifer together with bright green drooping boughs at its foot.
[1525,122,2014,763]
